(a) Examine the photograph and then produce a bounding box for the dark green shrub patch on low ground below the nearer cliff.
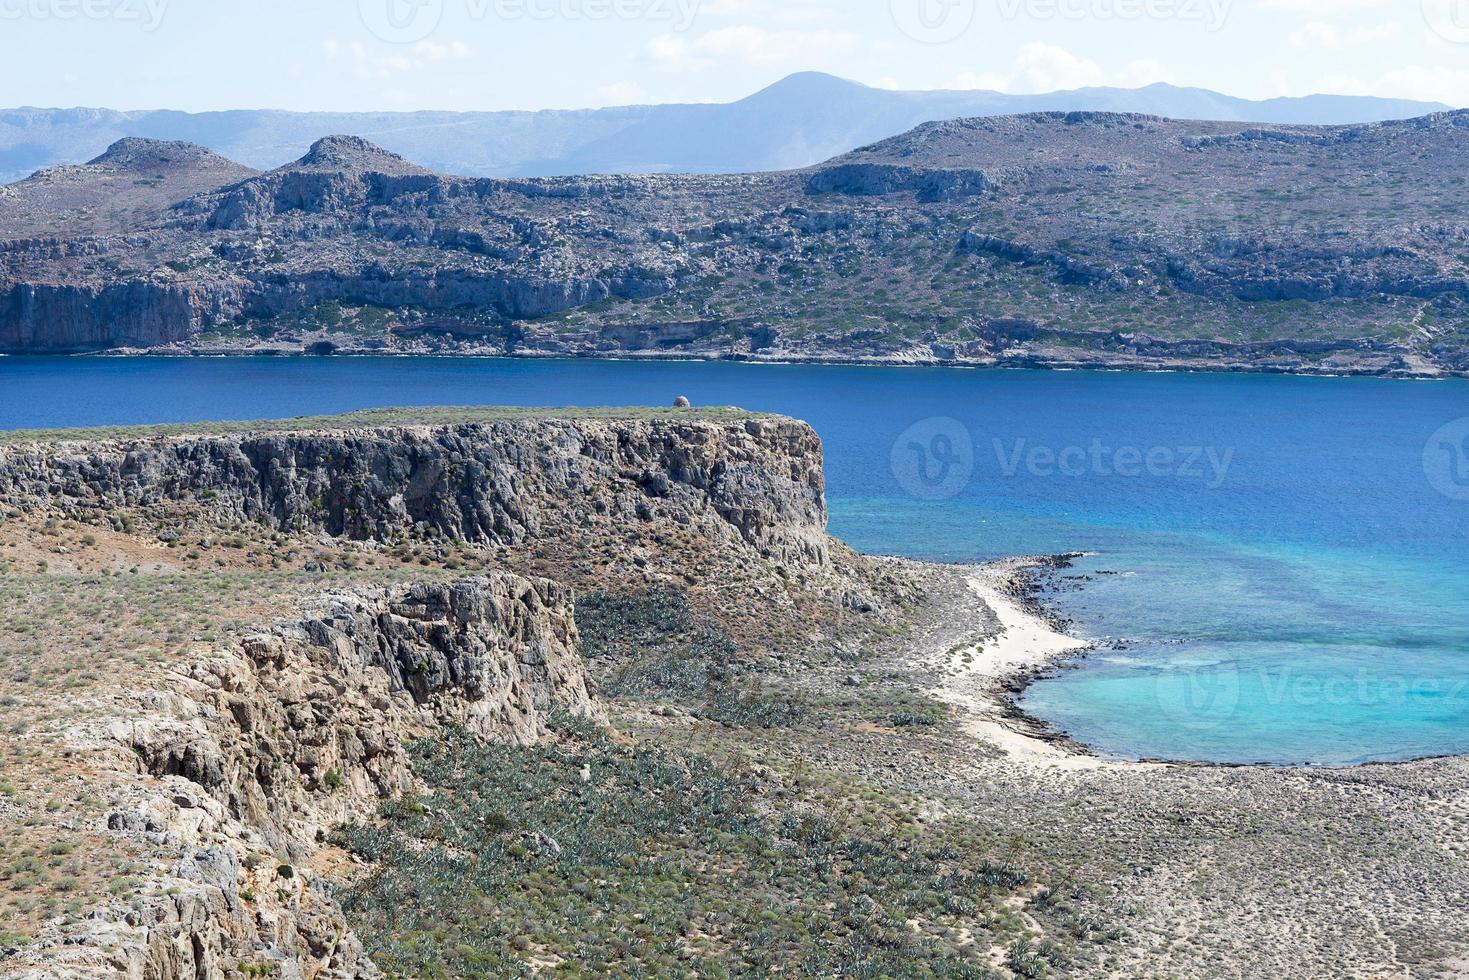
[333,720,1028,977]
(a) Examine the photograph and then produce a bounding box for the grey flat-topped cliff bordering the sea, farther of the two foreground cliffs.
[0,417,829,566]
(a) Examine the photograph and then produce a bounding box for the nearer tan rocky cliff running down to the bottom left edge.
[11,573,598,980]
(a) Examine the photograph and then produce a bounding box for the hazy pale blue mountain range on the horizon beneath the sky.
[0,72,1445,182]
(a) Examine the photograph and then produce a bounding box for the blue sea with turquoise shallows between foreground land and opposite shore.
[0,357,1469,765]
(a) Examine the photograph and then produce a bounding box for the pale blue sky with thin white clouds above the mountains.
[0,0,1469,112]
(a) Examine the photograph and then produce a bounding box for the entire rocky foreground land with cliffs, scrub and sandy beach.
[0,408,1469,980]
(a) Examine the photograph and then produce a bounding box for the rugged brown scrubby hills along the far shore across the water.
[0,112,1469,376]
